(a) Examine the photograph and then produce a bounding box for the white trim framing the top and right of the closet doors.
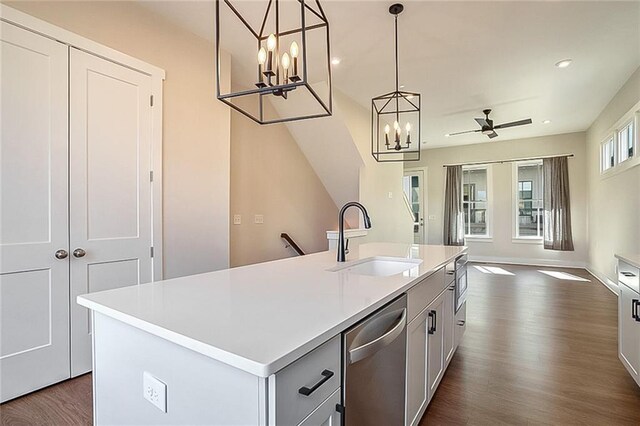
[0,4,166,281]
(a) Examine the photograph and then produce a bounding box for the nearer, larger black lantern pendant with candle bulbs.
[215,0,332,124]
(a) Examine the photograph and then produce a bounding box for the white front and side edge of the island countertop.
[77,246,467,378]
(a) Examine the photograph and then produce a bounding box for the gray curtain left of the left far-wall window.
[442,166,464,246]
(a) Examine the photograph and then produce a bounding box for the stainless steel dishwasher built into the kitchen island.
[342,295,407,426]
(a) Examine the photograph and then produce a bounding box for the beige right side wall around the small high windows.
[587,68,640,283]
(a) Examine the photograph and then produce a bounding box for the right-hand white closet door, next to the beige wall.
[69,48,152,376]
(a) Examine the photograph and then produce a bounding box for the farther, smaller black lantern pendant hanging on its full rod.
[371,3,421,162]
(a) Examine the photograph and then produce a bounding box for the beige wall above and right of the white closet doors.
[5,1,230,278]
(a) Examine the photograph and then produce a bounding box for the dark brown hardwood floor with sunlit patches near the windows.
[0,264,640,426]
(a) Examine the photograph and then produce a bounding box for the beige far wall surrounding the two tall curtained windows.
[408,133,588,266]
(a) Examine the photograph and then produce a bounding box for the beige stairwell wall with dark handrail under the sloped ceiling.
[230,106,338,266]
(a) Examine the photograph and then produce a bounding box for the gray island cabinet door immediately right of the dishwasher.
[405,309,428,425]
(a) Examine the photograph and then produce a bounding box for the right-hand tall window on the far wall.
[515,160,544,239]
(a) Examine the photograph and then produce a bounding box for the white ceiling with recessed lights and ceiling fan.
[141,0,640,148]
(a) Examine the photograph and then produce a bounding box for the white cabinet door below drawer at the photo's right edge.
[618,283,640,385]
